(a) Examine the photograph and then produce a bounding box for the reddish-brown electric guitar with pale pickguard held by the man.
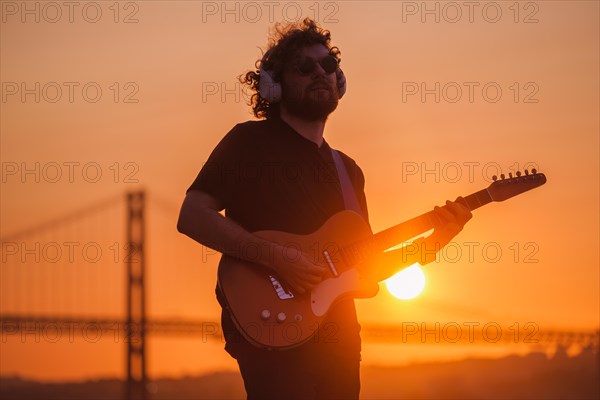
[218,169,546,350]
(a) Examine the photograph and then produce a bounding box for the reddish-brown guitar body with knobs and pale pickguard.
[218,210,379,349]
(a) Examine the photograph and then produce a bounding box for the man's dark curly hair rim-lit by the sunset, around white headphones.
[239,18,341,119]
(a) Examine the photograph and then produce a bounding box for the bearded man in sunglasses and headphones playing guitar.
[178,19,471,399]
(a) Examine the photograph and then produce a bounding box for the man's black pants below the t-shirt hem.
[232,340,360,400]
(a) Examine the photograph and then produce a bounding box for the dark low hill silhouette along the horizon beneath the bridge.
[0,348,600,400]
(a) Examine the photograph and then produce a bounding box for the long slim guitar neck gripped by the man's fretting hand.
[344,189,492,263]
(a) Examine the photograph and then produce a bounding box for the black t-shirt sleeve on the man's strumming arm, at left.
[186,125,244,208]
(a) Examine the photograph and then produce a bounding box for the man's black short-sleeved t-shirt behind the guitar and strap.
[188,119,368,357]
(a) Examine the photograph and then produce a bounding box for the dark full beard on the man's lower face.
[281,81,339,121]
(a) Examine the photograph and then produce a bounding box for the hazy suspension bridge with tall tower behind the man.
[0,191,598,399]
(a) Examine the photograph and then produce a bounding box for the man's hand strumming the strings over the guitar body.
[267,245,328,294]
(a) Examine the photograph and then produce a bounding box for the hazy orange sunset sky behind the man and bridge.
[0,1,600,379]
